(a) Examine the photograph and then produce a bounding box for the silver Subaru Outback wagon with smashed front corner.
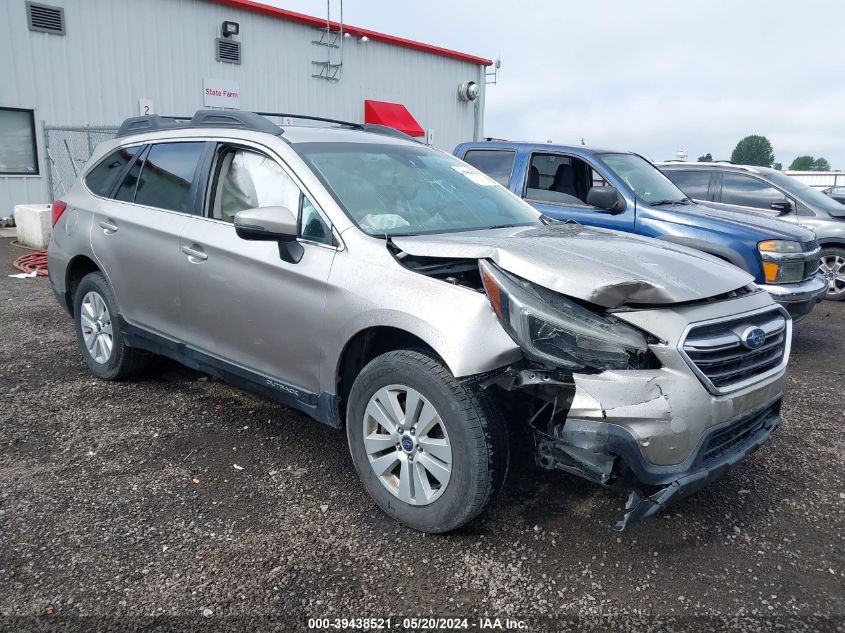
[49,111,792,532]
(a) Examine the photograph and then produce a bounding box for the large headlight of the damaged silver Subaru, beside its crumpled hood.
[478,261,659,371]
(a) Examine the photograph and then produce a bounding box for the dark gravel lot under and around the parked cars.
[0,239,845,631]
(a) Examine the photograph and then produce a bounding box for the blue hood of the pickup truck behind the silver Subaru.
[650,202,816,242]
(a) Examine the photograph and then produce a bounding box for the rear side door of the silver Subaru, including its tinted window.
[91,141,207,339]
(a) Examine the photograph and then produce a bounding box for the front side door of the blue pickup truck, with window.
[522,152,635,232]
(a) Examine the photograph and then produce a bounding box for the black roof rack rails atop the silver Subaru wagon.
[115,110,421,143]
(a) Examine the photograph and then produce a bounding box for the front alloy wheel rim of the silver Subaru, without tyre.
[364,385,452,506]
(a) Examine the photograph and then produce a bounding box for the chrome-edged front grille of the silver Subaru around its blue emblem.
[680,308,792,393]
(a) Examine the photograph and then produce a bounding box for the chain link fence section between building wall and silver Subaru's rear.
[44,125,117,200]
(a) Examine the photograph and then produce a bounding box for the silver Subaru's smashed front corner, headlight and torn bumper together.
[479,261,780,530]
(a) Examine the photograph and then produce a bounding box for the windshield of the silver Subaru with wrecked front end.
[294,143,540,236]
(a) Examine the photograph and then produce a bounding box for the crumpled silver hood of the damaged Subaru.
[393,224,754,308]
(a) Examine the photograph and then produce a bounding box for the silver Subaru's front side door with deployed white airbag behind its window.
[179,143,337,397]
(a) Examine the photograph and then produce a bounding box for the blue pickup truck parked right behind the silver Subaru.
[454,141,827,321]
